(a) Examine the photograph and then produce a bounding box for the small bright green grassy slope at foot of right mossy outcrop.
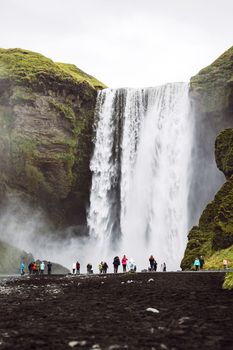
[205,246,233,270]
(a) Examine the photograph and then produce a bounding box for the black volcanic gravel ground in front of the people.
[0,272,233,350]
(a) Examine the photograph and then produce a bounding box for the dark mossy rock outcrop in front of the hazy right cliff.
[181,129,233,269]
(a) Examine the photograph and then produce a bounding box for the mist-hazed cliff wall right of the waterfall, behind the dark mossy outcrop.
[187,47,233,225]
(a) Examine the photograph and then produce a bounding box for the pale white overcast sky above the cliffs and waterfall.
[0,0,233,87]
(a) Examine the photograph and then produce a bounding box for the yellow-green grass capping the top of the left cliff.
[0,49,106,89]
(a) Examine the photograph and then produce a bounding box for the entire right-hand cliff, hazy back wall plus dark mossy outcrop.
[181,47,233,269]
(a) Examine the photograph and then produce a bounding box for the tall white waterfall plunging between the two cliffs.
[88,83,193,270]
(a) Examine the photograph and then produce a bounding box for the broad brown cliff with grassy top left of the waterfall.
[0,49,105,227]
